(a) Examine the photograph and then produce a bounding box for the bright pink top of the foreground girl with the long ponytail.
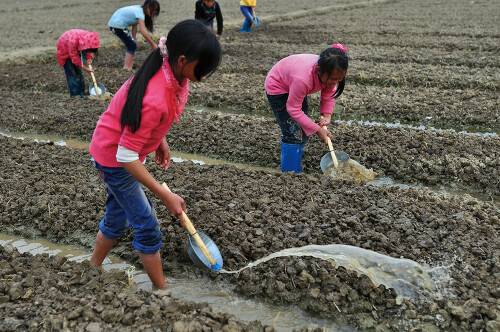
[89,60,189,167]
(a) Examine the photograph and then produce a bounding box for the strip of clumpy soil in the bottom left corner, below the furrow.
[0,246,272,332]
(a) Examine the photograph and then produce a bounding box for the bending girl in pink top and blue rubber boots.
[265,44,349,173]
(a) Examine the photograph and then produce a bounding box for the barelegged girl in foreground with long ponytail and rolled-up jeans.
[89,20,222,287]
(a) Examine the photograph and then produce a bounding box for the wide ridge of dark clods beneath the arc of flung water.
[0,138,500,330]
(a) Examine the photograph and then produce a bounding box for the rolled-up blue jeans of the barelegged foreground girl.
[93,161,162,254]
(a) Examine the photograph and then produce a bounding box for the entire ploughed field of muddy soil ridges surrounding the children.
[0,0,500,331]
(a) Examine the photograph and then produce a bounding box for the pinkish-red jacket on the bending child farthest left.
[57,29,101,67]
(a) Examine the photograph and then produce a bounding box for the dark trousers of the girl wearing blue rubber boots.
[266,92,309,144]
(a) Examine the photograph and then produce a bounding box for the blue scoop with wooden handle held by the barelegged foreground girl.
[162,182,223,271]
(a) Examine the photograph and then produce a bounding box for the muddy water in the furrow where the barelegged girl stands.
[0,233,356,331]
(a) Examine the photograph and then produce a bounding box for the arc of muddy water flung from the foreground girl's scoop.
[221,244,435,304]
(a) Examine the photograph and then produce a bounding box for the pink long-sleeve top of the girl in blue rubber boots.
[265,54,337,136]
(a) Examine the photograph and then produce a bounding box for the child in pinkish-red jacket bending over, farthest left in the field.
[57,29,101,98]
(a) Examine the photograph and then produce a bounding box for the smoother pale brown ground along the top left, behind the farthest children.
[0,0,364,60]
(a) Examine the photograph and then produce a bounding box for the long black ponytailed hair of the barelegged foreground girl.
[121,20,222,132]
